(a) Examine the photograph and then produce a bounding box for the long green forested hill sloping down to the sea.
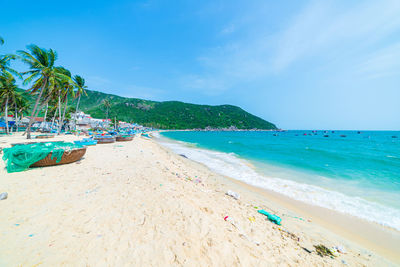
[18,90,276,129]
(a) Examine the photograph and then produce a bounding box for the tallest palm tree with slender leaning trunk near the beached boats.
[17,45,70,139]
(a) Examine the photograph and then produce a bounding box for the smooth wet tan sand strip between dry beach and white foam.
[156,133,400,264]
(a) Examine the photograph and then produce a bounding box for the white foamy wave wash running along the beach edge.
[158,136,400,231]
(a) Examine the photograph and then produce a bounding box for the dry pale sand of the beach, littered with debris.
[0,136,391,266]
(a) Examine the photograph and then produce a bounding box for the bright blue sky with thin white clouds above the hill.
[0,0,400,130]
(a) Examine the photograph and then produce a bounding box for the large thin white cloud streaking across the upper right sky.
[181,0,400,94]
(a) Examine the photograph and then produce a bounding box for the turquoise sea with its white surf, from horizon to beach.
[160,131,400,230]
